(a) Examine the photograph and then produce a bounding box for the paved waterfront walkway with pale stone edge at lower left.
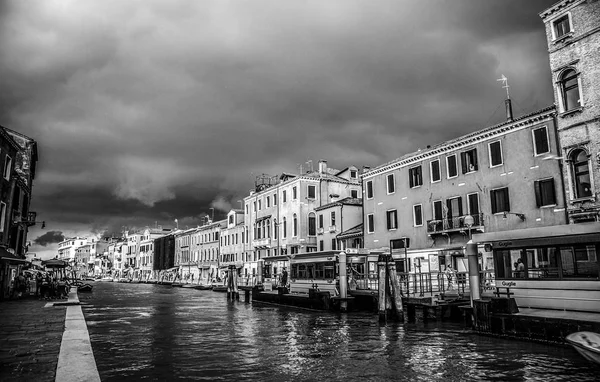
[0,288,100,382]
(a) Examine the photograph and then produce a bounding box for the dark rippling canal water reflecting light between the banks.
[79,282,600,381]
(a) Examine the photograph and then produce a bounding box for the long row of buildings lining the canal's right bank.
[61,0,600,308]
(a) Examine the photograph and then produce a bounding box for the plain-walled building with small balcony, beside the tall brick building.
[363,107,566,272]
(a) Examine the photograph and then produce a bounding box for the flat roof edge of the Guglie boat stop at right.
[473,222,600,248]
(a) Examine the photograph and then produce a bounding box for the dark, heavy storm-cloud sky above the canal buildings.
[0,0,555,255]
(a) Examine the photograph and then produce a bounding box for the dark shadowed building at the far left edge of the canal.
[0,126,43,299]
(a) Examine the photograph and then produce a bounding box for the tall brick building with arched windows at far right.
[540,0,600,223]
